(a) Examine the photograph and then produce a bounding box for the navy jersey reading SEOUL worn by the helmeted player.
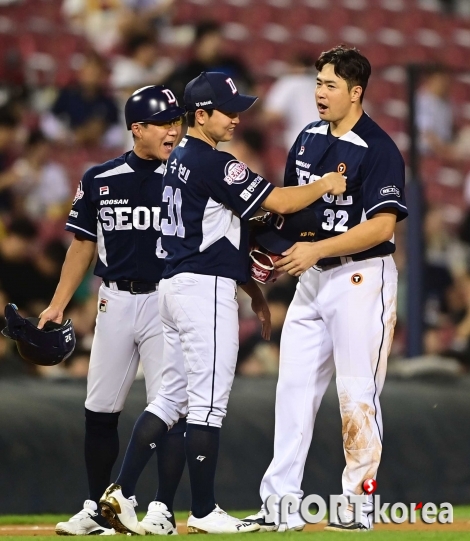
[65,151,165,282]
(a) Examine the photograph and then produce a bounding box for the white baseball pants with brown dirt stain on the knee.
[260,256,397,527]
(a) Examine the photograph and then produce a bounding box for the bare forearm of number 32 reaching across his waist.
[314,213,396,259]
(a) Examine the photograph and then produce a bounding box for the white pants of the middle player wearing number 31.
[146,272,238,427]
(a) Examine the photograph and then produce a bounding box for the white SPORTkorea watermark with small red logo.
[265,479,454,524]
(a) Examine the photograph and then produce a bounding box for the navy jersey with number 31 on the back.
[161,137,274,283]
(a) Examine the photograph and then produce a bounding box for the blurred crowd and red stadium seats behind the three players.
[0,0,470,378]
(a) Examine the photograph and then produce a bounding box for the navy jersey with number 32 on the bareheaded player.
[284,113,408,265]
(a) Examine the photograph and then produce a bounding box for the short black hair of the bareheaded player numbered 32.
[315,45,372,102]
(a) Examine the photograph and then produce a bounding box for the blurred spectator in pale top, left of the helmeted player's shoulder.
[9,130,72,220]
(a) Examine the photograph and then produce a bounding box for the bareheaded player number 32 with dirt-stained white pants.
[244,46,407,531]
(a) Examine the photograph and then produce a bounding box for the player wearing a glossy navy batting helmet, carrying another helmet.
[40,86,185,535]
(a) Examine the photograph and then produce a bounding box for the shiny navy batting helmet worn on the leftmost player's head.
[124,85,186,130]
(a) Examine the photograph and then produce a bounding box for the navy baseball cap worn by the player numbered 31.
[184,71,258,113]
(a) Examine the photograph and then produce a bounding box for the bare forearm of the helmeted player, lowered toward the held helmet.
[50,238,96,311]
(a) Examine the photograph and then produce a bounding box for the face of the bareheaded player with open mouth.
[315,64,362,124]
